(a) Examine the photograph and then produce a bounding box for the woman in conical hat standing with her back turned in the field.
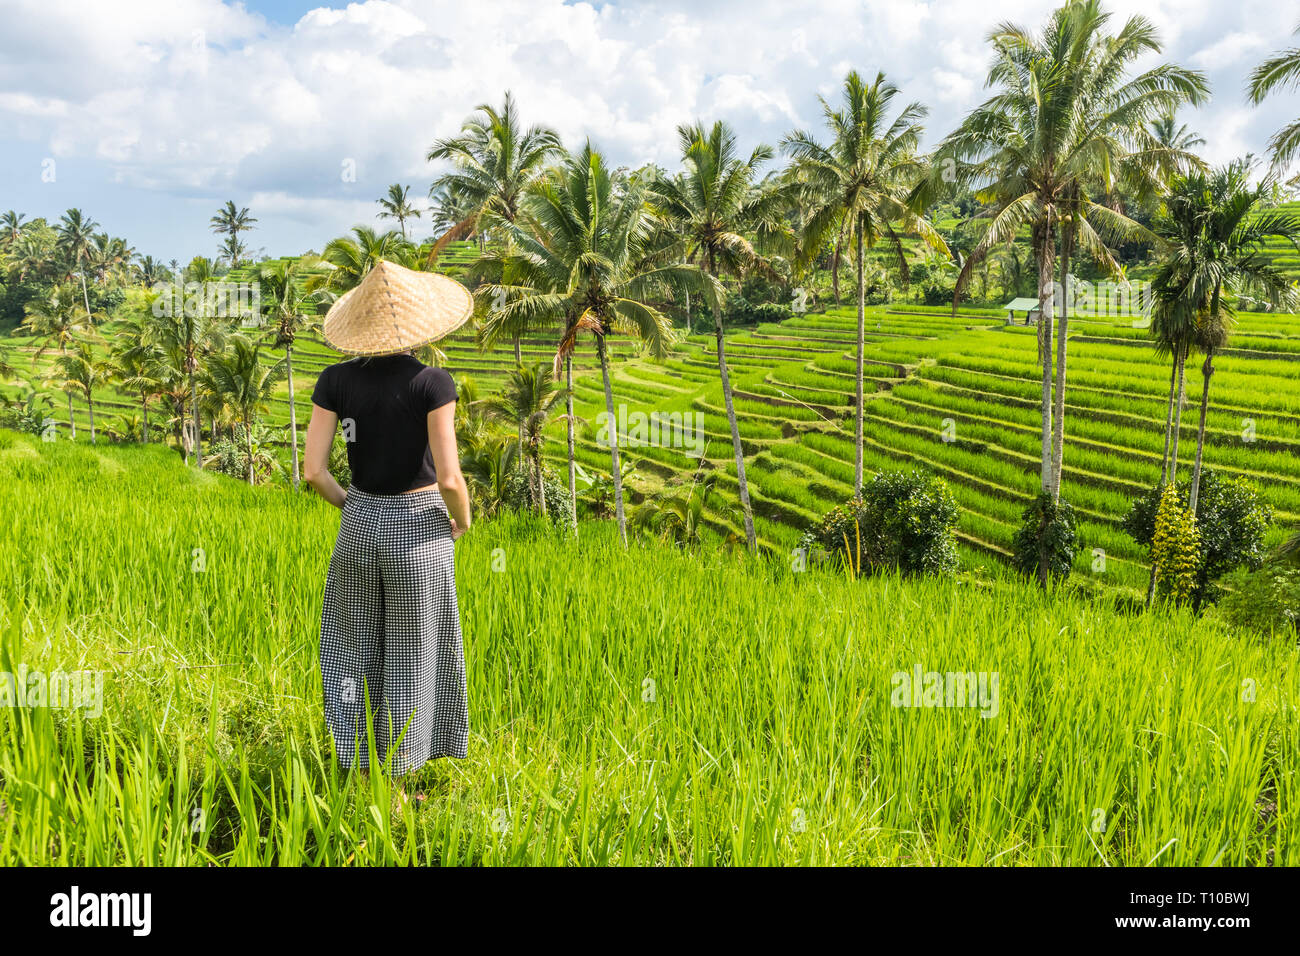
[303,261,473,775]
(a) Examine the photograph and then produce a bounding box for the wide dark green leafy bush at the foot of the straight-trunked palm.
[801,471,959,575]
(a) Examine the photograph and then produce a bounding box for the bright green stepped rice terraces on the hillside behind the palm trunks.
[0,265,1300,598]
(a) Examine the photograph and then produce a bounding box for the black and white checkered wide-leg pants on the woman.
[321,486,469,775]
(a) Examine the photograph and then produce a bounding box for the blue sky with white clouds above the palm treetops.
[0,0,1300,261]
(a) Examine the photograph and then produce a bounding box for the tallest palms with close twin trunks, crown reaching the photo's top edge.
[940,0,1208,522]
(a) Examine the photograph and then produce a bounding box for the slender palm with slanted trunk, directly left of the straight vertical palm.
[650,121,789,551]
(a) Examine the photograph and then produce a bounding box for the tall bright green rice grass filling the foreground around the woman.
[0,433,1300,865]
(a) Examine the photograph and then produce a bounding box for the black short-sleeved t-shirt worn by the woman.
[312,354,456,494]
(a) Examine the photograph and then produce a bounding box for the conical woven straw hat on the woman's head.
[324,260,475,355]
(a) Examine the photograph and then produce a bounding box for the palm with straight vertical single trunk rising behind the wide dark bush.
[781,72,948,493]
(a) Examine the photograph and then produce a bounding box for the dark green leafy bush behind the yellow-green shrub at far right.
[1123,468,1273,610]
